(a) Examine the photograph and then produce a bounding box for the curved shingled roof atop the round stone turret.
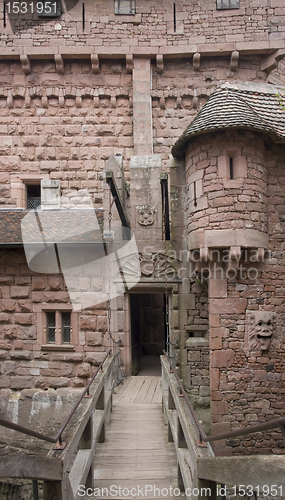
[172,83,285,158]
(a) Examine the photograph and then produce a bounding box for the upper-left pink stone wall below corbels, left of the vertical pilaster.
[0,61,133,208]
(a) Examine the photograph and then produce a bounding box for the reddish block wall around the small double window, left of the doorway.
[0,249,107,390]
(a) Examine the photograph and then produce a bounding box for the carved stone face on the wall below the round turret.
[245,311,277,351]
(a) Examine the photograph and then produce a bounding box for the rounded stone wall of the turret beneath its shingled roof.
[186,131,267,237]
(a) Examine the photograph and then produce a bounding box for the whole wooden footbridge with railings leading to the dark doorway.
[0,356,285,500]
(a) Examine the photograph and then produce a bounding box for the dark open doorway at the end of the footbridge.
[131,293,166,375]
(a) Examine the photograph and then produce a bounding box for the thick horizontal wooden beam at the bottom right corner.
[197,455,285,488]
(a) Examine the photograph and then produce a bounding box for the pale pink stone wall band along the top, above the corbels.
[0,0,285,47]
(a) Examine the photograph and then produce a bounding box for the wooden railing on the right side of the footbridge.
[161,355,285,500]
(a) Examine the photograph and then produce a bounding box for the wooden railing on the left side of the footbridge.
[0,356,114,500]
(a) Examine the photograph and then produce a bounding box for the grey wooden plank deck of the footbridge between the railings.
[94,376,183,500]
